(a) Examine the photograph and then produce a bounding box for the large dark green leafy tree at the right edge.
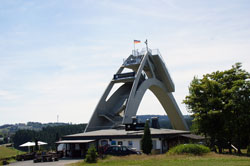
[183,63,250,153]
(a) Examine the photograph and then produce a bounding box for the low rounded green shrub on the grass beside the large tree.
[168,144,210,155]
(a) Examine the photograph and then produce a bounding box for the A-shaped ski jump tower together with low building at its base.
[56,47,204,158]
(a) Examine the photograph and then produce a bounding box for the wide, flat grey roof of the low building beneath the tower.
[64,128,190,139]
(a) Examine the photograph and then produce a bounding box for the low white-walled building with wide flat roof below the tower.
[57,128,203,157]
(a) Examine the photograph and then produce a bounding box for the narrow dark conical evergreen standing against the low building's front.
[141,121,153,154]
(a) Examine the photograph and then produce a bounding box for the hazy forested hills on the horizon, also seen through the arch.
[0,115,193,146]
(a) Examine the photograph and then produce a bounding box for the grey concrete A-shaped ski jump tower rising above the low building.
[85,49,188,132]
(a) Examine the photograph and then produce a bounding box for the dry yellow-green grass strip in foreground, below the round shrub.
[72,153,250,166]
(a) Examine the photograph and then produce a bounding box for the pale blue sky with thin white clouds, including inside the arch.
[0,0,250,125]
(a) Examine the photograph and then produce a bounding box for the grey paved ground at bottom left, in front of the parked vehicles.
[10,159,82,166]
